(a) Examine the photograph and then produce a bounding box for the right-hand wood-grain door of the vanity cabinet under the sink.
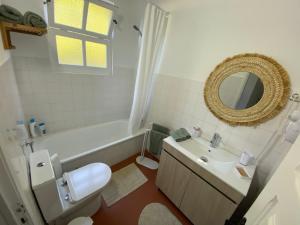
[180,174,236,225]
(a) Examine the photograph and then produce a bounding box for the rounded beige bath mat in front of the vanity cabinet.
[139,203,182,225]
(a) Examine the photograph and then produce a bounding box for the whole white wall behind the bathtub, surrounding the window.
[6,0,145,132]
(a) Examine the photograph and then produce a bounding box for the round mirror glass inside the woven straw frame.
[219,72,264,110]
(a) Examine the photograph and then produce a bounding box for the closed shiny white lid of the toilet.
[63,163,111,202]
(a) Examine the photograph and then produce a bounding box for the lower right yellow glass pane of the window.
[85,41,107,68]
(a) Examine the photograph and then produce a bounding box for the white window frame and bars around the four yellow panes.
[45,0,115,75]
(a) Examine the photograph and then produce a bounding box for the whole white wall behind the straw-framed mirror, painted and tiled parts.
[149,0,300,183]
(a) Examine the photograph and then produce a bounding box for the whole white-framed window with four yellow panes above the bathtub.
[47,0,114,74]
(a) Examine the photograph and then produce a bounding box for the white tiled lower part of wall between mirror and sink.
[148,75,287,185]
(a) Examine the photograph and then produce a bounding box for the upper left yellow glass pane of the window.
[54,0,84,29]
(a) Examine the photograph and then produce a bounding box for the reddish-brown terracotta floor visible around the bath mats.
[92,153,192,225]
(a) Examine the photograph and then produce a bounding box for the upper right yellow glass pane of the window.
[86,3,113,35]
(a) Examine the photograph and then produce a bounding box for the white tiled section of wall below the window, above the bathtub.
[13,56,135,132]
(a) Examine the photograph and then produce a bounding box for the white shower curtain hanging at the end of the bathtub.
[129,3,168,133]
